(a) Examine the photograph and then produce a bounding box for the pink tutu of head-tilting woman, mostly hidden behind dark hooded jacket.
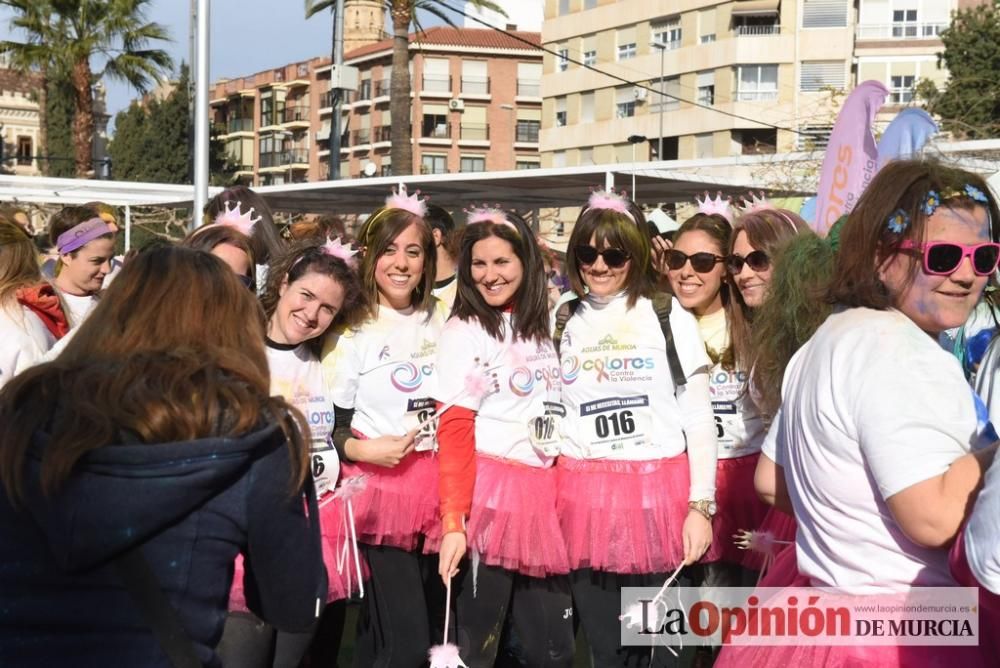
[229,495,368,612]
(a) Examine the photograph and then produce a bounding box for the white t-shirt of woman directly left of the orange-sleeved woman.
[323,302,445,450]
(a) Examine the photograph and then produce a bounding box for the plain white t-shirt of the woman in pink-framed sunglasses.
[769,308,980,591]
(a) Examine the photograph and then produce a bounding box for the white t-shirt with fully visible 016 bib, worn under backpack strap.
[559,295,711,460]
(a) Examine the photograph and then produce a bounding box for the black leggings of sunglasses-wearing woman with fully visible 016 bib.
[569,568,688,668]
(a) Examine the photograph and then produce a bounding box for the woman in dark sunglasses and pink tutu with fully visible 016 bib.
[554,192,725,667]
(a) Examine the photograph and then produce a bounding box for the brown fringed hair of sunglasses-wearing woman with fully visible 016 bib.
[566,194,656,308]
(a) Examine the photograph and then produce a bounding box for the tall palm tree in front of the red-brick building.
[306,0,507,176]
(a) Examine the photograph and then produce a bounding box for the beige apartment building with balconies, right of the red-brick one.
[541,0,977,167]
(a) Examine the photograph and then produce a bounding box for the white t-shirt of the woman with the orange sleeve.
[434,313,565,468]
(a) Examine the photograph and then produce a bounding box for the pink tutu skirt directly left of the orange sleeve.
[340,452,441,553]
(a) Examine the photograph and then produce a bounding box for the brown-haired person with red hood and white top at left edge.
[0,214,69,387]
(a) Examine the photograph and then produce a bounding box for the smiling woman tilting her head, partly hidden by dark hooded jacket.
[216,237,365,668]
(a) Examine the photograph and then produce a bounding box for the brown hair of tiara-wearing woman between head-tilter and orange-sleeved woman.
[358,207,437,318]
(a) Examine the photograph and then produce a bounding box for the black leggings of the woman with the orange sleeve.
[452,560,574,668]
